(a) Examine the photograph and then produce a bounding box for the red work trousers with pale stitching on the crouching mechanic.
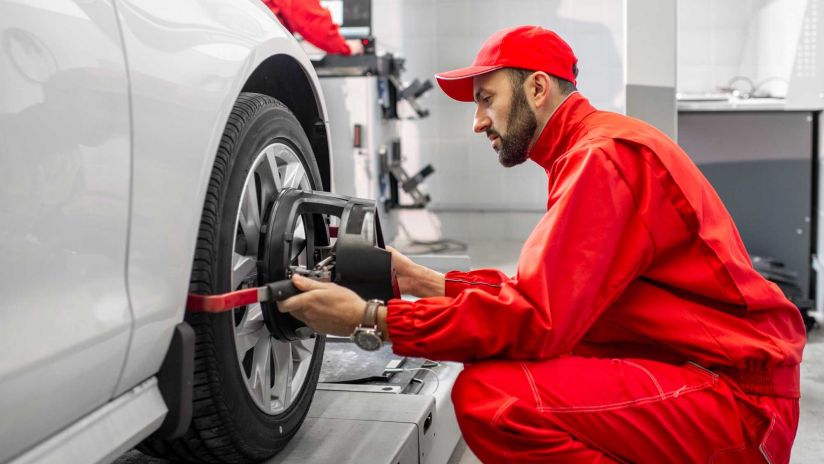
[452,356,798,464]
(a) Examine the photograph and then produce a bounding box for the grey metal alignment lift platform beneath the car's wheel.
[268,255,470,464]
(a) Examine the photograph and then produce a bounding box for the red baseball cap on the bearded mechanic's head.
[435,26,578,102]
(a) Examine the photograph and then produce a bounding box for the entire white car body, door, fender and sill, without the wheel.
[0,0,329,462]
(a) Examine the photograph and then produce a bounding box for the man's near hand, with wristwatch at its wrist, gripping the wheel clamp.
[278,275,366,337]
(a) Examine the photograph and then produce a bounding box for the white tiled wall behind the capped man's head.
[372,0,624,238]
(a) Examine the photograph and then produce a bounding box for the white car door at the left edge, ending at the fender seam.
[0,0,131,462]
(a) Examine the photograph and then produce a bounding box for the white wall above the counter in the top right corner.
[677,0,807,96]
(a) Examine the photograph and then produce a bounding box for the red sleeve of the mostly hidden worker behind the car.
[263,0,351,55]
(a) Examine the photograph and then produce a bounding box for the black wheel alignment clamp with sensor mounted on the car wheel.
[258,189,400,341]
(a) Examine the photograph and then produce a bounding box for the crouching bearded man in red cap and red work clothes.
[281,26,805,463]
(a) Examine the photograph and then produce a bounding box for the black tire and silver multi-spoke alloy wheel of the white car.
[140,93,324,463]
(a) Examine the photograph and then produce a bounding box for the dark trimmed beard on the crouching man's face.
[487,89,538,168]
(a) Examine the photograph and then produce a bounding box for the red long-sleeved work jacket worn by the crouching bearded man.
[387,93,805,398]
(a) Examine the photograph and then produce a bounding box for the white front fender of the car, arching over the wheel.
[116,0,328,392]
